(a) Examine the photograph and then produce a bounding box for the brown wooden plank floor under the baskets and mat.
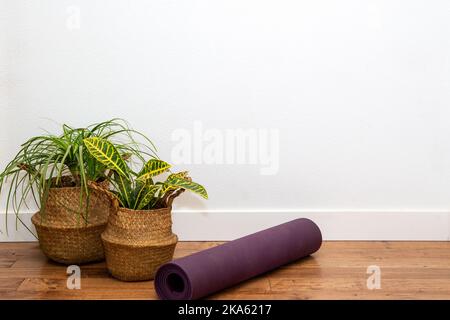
[0,242,450,299]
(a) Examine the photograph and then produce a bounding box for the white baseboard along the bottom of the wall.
[0,210,450,242]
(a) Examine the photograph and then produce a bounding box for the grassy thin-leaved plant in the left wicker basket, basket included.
[0,119,155,264]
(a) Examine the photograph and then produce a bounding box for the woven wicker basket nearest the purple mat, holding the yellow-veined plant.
[102,205,178,281]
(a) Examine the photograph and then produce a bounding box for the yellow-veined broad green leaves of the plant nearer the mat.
[84,137,208,210]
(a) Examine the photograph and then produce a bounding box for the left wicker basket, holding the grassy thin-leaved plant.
[31,179,116,264]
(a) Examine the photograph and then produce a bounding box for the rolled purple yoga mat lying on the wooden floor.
[155,219,322,300]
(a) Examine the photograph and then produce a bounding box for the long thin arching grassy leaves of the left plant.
[0,119,156,234]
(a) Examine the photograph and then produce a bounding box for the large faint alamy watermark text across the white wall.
[171,121,280,175]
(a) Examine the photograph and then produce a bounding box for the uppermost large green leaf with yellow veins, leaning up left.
[83,137,129,179]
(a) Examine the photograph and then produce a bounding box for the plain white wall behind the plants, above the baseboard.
[0,0,450,239]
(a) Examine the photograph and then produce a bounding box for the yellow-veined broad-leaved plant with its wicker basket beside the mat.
[84,137,208,281]
